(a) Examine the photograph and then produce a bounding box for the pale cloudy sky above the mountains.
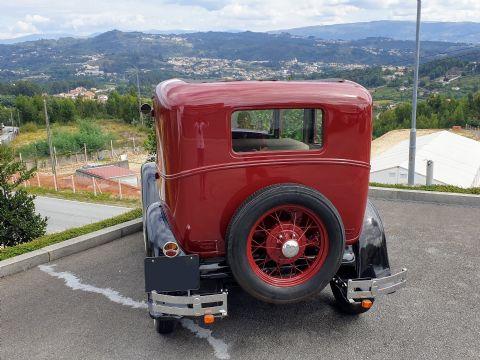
[0,0,480,39]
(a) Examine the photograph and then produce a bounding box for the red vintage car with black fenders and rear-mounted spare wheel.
[142,80,406,333]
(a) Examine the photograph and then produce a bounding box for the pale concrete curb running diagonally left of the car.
[0,219,142,279]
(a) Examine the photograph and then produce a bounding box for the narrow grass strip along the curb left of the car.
[0,209,142,260]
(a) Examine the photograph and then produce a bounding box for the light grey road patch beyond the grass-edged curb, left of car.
[35,196,130,233]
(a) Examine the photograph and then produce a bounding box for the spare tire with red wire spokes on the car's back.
[227,184,345,304]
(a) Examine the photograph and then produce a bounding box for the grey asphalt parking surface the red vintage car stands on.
[0,201,480,360]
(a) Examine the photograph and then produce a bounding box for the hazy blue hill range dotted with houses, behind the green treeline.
[0,30,480,81]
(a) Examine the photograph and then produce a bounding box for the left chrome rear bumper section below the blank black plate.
[148,291,228,317]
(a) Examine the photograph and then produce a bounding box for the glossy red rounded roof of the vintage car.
[155,79,372,109]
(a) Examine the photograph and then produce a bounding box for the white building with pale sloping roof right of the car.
[370,131,480,188]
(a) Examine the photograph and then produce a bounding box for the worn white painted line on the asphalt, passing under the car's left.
[38,265,230,360]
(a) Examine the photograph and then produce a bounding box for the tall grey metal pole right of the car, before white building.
[408,0,422,186]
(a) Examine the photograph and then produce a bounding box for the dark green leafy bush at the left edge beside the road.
[0,146,47,246]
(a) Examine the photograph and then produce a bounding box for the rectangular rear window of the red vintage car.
[231,109,323,152]
